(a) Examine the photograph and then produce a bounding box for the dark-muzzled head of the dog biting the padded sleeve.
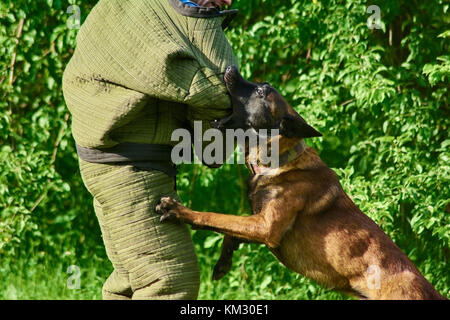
[211,66,322,138]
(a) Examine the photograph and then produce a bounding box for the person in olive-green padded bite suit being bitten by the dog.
[63,0,237,299]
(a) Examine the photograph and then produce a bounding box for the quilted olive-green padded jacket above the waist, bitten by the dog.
[63,0,237,148]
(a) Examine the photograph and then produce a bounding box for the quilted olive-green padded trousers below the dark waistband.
[80,159,200,300]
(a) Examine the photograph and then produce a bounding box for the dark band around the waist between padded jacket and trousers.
[76,142,177,177]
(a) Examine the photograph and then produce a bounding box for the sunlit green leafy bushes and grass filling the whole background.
[0,0,450,299]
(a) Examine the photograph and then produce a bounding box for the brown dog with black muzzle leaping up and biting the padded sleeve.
[156,66,445,299]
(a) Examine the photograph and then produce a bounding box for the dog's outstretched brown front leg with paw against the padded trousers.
[156,197,280,248]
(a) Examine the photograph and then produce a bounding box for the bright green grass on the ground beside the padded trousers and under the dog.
[0,231,348,300]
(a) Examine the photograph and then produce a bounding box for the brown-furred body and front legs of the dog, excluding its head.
[157,108,445,299]
